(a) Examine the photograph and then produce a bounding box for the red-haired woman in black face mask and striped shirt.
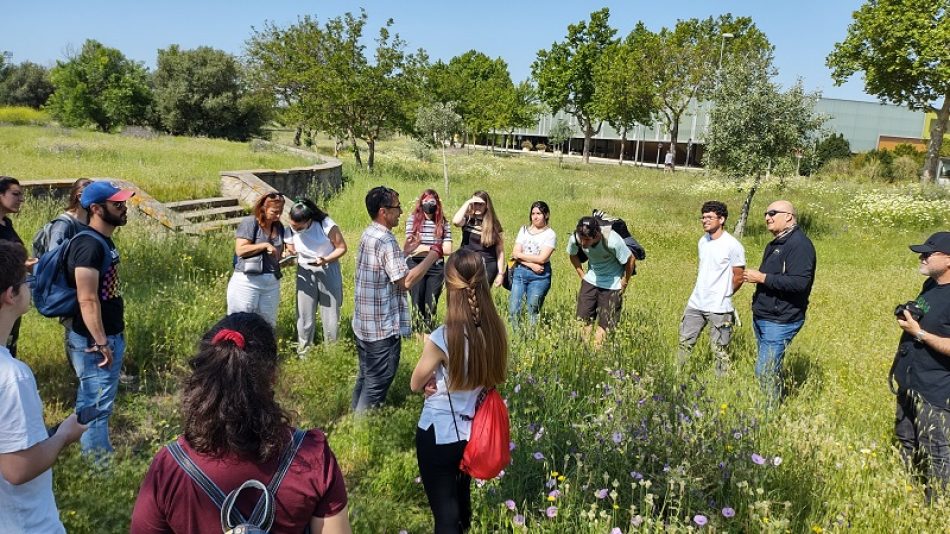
[406,189,452,333]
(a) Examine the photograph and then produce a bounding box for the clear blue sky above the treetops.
[0,0,876,101]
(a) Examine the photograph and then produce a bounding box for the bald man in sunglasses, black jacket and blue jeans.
[744,200,815,402]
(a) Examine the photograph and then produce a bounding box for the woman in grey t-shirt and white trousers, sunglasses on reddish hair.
[228,193,293,326]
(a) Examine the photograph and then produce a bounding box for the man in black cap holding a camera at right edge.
[891,232,950,500]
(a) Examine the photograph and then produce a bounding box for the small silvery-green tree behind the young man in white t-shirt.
[704,53,825,237]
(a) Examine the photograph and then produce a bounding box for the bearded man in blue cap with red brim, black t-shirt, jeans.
[66,181,135,453]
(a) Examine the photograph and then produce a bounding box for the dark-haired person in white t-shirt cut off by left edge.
[0,241,87,534]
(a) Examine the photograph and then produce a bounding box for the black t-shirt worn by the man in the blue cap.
[66,229,125,337]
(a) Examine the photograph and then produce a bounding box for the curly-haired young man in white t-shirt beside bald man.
[679,200,745,375]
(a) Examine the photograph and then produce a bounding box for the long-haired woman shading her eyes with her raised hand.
[452,191,505,287]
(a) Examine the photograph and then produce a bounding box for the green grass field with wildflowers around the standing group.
[0,127,950,533]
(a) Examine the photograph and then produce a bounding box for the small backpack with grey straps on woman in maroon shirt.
[166,428,310,534]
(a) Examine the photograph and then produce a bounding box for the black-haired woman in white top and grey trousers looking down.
[290,199,346,356]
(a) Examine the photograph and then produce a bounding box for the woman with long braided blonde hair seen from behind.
[410,249,508,533]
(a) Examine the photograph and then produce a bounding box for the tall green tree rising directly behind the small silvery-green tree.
[644,13,772,153]
